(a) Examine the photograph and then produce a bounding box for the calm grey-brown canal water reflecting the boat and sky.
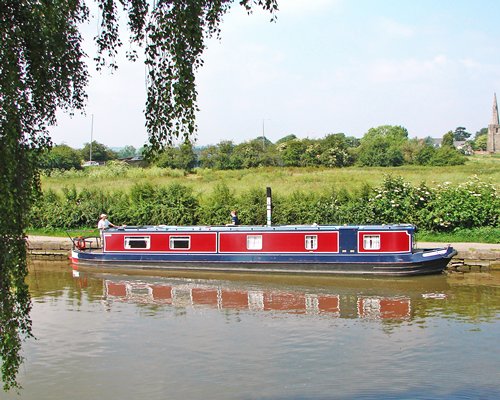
[4,262,500,400]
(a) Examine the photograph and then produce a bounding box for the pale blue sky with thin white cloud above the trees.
[50,0,500,148]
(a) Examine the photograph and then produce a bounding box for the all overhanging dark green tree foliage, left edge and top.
[0,0,277,390]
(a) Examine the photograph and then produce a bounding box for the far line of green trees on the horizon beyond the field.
[40,125,487,171]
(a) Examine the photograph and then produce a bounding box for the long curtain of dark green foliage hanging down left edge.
[0,0,88,390]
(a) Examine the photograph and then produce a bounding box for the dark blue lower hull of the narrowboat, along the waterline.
[72,247,456,276]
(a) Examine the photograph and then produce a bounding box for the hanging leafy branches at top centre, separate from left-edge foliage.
[131,0,277,154]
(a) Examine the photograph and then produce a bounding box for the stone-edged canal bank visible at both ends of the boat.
[26,236,500,270]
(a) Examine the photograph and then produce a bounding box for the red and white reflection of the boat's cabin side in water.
[104,278,411,320]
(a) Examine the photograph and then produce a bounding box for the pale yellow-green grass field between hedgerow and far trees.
[42,156,500,195]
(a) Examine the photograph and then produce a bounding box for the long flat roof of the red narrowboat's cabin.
[108,224,415,233]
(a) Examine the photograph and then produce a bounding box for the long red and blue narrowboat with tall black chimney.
[71,188,457,276]
